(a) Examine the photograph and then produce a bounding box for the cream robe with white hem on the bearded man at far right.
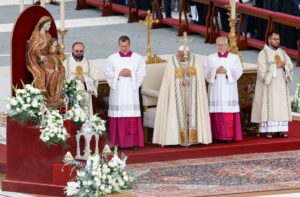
[251,45,293,132]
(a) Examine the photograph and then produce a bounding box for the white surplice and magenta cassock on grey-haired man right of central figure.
[205,52,243,141]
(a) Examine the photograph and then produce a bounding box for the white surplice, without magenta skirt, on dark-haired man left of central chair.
[104,53,146,117]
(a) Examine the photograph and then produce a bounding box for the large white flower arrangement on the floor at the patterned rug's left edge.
[65,149,134,197]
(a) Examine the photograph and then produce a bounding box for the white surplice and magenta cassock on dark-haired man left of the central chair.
[104,52,146,148]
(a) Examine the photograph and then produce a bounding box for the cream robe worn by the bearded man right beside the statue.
[64,55,98,116]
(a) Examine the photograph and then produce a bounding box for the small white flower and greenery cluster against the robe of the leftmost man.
[63,79,85,108]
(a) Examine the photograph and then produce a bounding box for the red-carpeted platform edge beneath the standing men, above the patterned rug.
[120,121,300,163]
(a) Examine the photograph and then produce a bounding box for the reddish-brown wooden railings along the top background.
[77,0,300,66]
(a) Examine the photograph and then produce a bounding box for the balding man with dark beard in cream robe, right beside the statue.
[64,42,98,116]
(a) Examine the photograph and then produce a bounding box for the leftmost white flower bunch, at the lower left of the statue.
[6,84,44,124]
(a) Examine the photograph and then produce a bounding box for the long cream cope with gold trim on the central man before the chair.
[153,55,212,145]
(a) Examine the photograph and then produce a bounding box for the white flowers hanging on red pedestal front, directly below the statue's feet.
[40,110,69,145]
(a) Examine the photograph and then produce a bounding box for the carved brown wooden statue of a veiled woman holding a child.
[27,16,65,108]
